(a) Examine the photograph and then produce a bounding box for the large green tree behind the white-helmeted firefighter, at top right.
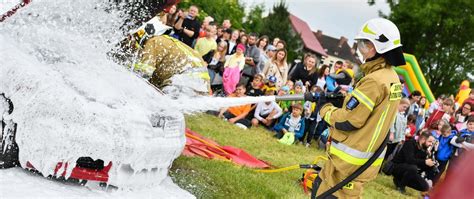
[369,0,474,96]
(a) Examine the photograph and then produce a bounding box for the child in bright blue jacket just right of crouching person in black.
[433,124,455,186]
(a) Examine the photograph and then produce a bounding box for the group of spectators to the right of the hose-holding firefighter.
[384,90,474,193]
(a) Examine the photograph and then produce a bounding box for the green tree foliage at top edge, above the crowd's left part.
[178,0,245,29]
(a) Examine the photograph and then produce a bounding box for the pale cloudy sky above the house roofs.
[240,0,390,45]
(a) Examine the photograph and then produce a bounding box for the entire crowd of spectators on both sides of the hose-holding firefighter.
[162,3,474,197]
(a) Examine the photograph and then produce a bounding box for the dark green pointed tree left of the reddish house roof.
[260,0,302,60]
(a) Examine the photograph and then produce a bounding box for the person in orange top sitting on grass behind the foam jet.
[218,84,251,129]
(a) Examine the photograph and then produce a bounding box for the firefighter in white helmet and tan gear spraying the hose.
[314,18,405,198]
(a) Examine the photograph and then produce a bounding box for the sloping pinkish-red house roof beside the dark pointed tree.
[290,14,327,56]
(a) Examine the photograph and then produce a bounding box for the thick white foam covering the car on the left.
[0,0,189,197]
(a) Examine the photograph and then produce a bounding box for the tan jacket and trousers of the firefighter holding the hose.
[320,57,402,186]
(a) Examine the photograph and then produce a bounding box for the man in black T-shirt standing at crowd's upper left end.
[174,5,201,47]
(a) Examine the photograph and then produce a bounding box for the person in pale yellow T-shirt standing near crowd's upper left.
[194,24,217,57]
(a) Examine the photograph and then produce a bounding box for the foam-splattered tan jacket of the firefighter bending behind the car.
[133,35,210,92]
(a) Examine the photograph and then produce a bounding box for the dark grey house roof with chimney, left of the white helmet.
[314,30,357,63]
